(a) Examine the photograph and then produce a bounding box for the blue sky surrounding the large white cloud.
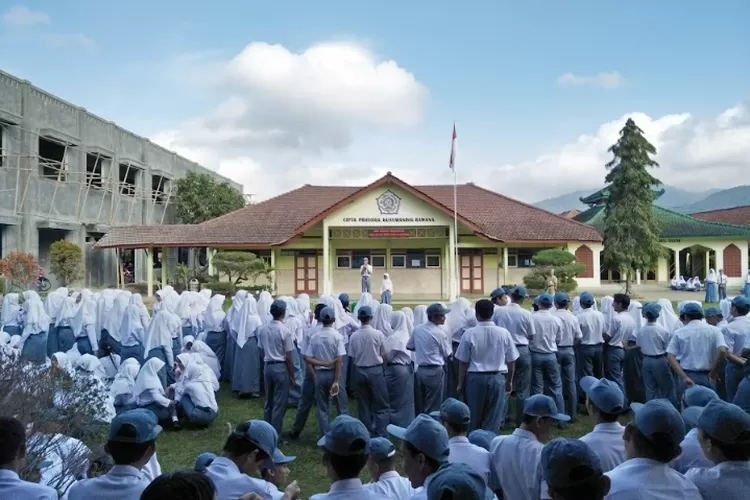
[0,0,750,201]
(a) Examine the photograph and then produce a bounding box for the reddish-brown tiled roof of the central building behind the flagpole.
[97,173,602,248]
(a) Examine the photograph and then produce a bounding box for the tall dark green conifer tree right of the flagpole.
[602,118,664,293]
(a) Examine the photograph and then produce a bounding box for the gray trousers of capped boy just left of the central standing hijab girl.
[354,365,391,437]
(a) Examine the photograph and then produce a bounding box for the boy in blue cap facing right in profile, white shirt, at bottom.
[490,394,570,500]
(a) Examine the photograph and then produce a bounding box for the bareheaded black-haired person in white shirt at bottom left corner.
[0,417,57,500]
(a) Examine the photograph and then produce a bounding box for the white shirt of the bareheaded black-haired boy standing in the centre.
[456,321,518,373]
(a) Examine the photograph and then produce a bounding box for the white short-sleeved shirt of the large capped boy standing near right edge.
[667,320,727,371]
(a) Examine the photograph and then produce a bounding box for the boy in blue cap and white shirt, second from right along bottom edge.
[607,399,701,500]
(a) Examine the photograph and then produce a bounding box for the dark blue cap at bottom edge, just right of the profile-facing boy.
[541,438,603,489]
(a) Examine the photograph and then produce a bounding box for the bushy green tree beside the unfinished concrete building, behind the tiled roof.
[174,172,245,224]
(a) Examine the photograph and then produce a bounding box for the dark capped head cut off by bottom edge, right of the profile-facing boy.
[541,438,610,500]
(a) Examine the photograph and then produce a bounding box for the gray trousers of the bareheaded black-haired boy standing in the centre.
[466,372,506,433]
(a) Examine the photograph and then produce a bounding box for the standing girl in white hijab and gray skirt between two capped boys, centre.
[388,312,414,427]
